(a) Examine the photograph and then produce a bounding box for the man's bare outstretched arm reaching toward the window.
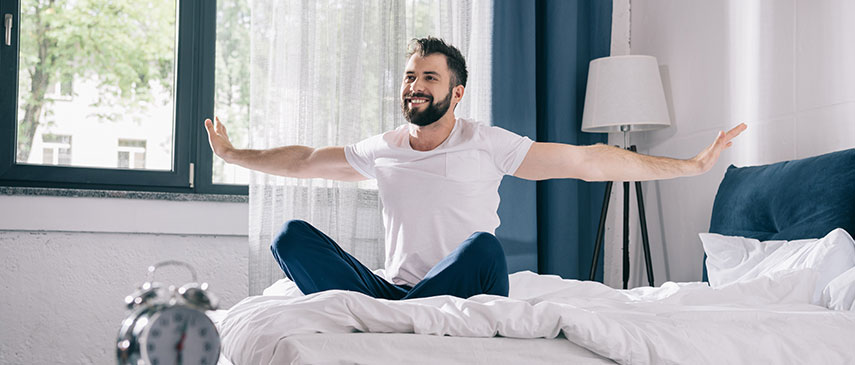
[205,118,367,181]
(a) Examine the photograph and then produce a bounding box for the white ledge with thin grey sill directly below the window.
[0,187,249,237]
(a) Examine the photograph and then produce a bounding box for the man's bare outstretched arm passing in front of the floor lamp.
[514,123,748,181]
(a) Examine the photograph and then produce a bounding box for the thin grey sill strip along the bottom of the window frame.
[0,186,249,203]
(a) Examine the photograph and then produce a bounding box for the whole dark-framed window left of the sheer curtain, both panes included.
[0,0,250,194]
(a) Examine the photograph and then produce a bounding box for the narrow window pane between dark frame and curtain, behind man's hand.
[213,0,250,184]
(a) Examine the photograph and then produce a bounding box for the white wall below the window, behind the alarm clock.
[0,196,248,364]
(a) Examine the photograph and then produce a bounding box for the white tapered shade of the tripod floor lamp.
[582,55,671,133]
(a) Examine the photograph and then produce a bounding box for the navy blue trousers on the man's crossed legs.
[270,220,508,300]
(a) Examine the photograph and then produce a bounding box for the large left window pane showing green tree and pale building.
[16,0,176,170]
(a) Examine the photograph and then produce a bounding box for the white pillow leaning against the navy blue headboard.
[699,228,855,304]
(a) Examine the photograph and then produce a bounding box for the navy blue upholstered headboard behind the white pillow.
[704,148,855,281]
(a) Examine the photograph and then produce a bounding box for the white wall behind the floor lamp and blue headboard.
[606,0,855,286]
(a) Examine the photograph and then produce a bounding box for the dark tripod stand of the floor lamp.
[589,144,653,289]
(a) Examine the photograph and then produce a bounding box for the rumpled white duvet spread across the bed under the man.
[219,270,855,364]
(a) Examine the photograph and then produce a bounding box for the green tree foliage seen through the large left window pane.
[18,0,176,161]
